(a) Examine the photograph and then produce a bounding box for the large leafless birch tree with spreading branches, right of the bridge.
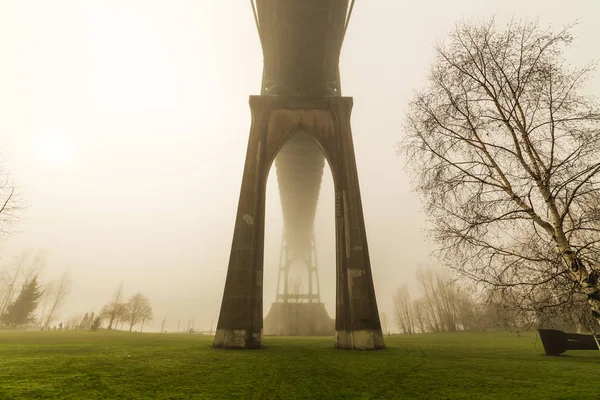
[402,19,600,326]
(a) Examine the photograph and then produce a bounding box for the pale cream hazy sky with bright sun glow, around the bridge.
[0,0,600,330]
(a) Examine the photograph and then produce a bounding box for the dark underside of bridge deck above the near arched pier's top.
[256,0,348,96]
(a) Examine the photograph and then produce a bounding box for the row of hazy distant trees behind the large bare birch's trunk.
[392,269,595,334]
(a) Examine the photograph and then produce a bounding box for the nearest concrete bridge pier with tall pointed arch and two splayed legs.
[214,96,384,350]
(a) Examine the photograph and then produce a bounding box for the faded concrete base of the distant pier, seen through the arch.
[263,303,335,336]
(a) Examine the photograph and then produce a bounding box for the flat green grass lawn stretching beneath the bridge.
[0,331,600,400]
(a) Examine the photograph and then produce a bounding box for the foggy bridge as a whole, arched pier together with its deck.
[214,0,384,350]
